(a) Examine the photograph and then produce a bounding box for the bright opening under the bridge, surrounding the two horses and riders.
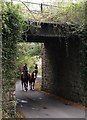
[16,42,43,90]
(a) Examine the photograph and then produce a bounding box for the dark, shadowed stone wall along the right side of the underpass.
[42,36,85,104]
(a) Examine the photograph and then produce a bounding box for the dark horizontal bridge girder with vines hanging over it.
[23,21,75,41]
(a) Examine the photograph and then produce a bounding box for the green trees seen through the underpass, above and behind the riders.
[17,42,41,77]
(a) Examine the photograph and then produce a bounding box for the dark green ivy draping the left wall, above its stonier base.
[2,3,24,80]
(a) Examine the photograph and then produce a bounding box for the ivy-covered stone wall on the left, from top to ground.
[1,3,24,118]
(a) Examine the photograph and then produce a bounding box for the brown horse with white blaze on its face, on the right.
[29,70,37,90]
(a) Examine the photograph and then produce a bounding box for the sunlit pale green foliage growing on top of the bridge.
[11,0,85,25]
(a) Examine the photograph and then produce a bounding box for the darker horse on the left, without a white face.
[21,71,30,91]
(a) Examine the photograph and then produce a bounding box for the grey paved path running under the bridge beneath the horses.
[16,78,85,118]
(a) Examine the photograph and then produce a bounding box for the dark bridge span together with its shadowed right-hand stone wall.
[24,21,85,104]
